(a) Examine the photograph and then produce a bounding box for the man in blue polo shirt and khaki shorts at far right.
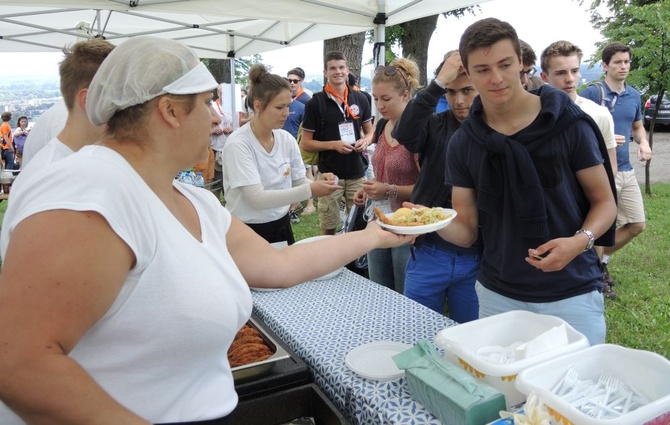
[580,42,651,298]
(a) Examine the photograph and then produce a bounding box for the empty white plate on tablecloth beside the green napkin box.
[344,341,412,381]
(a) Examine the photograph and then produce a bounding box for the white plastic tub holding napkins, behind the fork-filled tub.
[435,310,589,411]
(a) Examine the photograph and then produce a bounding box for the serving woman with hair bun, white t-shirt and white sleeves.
[223,64,337,245]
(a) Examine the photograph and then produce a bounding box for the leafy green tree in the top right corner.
[591,0,670,194]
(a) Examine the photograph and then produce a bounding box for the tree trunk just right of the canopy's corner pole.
[400,15,438,86]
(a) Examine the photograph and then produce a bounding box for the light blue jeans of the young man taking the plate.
[475,281,607,345]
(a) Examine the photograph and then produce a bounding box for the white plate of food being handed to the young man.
[375,207,457,235]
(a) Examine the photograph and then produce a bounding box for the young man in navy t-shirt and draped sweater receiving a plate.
[439,18,616,344]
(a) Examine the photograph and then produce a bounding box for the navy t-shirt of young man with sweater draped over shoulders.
[446,89,603,302]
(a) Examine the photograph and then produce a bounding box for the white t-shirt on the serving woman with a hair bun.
[223,123,310,223]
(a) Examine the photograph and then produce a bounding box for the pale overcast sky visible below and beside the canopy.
[0,0,602,78]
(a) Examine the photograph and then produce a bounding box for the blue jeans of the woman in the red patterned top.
[368,244,410,294]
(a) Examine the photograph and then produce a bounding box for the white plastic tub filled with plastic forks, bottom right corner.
[516,344,670,425]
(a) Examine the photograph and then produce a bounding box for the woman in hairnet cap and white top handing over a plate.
[0,37,414,425]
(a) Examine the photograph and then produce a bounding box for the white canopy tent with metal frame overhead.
[0,0,487,125]
